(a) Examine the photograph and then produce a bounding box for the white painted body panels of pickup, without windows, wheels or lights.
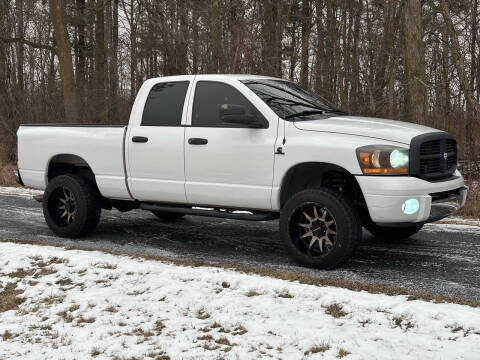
[18,75,466,223]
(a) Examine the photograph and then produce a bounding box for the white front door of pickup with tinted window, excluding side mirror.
[185,76,278,209]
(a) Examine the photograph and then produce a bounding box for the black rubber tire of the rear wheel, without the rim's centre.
[43,174,101,238]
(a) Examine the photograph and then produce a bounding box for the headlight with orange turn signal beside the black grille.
[357,145,408,175]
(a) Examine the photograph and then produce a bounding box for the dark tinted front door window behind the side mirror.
[192,81,262,128]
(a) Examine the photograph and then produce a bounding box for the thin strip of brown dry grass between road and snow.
[0,239,480,307]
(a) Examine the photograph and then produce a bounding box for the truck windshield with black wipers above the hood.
[242,79,346,121]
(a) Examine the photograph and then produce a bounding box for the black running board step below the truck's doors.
[140,204,279,221]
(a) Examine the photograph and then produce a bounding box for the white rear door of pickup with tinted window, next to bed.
[126,76,194,203]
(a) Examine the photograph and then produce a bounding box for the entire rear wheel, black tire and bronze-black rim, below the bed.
[43,174,101,238]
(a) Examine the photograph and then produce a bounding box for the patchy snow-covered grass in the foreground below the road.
[0,242,480,360]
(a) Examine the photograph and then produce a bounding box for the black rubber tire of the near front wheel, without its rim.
[280,189,362,269]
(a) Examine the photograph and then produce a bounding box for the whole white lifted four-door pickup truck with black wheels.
[15,75,467,268]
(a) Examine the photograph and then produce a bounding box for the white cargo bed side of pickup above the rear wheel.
[17,123,130,199]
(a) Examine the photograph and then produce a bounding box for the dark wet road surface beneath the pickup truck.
[0,195,480,299]
